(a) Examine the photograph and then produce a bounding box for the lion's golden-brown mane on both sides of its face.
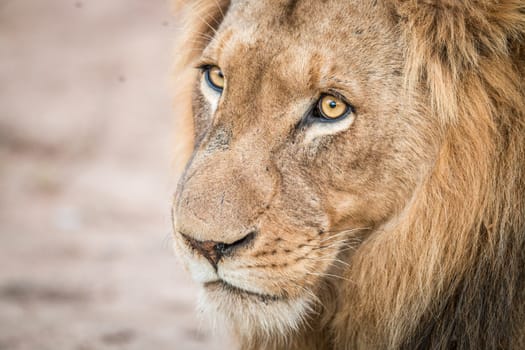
[176,0,525,349]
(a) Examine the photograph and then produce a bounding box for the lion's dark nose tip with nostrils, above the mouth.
[182,231,256,268]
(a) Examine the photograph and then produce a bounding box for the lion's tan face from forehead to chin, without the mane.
[174,0,432,340]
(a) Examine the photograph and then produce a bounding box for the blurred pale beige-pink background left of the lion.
[0,0,224,350]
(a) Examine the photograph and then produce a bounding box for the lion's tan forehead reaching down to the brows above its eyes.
[202,0,404,119]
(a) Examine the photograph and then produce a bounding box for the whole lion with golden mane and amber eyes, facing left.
[173,0,525,350]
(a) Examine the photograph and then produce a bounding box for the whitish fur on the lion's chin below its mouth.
[197,288,312,341]
